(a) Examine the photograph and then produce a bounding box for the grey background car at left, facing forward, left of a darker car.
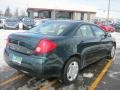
[4,18,20,30]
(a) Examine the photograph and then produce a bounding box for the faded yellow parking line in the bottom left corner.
[0,74,25,87]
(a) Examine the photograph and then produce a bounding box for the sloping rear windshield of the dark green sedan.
[28,21,74,36]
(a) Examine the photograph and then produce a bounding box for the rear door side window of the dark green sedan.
[80,25,94,38]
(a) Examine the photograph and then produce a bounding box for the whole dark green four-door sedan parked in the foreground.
[4,20,116,84]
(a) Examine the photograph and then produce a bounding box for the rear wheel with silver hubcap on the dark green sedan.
[62,57,79,85]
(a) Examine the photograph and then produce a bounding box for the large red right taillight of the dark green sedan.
[34,39,57,54]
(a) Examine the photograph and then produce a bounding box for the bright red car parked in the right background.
[96,22,115,32]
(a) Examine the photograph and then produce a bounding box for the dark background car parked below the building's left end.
[22,17,35,30]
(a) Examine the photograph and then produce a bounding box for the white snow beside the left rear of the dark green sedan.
[0,29,23,70]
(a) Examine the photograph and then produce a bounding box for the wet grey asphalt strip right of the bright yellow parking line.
[97,48,120,90]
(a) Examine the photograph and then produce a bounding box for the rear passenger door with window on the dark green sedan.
[76,24,100,66]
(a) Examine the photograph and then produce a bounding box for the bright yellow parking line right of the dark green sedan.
[89,60,113,90]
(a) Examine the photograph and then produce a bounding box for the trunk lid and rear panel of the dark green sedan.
[9,32,56,55]
